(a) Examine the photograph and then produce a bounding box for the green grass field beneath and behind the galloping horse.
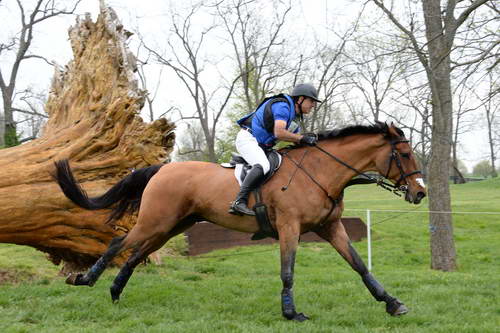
[0,179,500,333]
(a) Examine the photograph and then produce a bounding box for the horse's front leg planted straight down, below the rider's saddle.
[278,221,309,321]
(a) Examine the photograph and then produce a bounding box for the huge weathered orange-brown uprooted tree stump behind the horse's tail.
[0,2,174,270]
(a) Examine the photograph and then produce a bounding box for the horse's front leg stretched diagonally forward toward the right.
[316,219,408,316]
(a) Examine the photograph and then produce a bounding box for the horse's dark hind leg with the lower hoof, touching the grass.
[109,219,196,303]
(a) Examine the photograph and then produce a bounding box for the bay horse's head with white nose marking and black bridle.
[376,123,427,204]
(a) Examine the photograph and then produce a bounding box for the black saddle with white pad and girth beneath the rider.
[221,150,282,240]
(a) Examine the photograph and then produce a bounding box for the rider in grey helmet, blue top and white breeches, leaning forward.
[229,83,321,216]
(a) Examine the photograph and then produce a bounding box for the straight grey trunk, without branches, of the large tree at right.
[423,0,456,271]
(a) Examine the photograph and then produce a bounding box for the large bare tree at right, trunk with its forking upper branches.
[372,0,492,271]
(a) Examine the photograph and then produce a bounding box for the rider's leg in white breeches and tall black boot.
[229,130,270,216]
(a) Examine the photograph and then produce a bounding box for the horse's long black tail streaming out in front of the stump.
[52,159,162,223]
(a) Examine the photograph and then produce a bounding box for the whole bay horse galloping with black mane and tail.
[53,122,426,321]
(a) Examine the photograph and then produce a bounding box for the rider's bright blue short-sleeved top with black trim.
[237,95,300,147]
